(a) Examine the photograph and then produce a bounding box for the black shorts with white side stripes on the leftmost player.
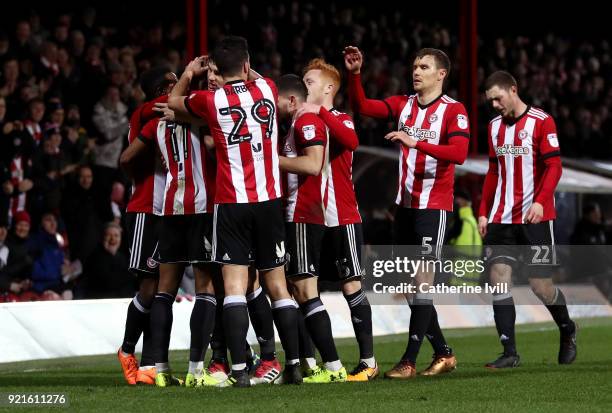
[125,212,159,277]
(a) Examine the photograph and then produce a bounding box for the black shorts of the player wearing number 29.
[212,199,286,270]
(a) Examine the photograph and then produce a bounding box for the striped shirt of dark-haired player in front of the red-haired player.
[282,113,328,225]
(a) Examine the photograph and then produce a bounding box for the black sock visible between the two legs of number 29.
[247,287,276,360]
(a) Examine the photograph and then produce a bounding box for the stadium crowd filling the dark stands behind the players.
[0,0,612,301]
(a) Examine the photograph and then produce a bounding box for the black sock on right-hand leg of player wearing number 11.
[189,293,217,362]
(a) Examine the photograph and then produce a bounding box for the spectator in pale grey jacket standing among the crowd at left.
[93,85,129,188]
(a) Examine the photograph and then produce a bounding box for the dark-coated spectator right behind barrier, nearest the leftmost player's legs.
[78,222,136,298]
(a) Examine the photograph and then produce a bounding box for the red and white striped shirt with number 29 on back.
[185,79,281,204]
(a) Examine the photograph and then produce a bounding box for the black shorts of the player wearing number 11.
[157,214,213,264]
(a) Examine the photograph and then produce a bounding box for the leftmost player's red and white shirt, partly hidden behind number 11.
[126,96,168,215]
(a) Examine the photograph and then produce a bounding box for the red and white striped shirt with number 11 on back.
[139,119,215,215]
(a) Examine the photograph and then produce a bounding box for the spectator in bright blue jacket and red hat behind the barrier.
[29,212,72,300]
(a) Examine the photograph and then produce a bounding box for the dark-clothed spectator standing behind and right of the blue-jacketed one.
[62,166,113,263]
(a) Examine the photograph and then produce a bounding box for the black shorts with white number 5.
[393,207,448,259]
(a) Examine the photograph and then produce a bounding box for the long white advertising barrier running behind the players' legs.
[0,285,612,363]
